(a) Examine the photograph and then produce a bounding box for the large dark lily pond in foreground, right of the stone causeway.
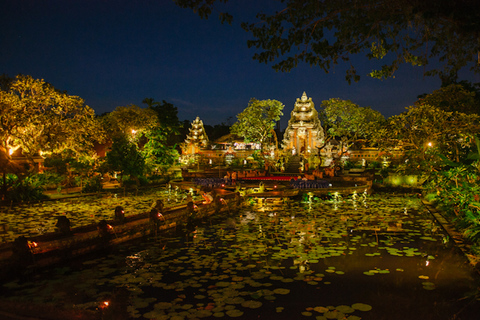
[2,194,480,320]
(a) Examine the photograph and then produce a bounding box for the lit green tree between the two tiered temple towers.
[230,98,285,149]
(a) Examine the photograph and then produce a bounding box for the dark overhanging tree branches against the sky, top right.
[175,0,480,82]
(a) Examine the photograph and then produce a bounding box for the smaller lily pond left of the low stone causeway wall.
[0,187,202,242]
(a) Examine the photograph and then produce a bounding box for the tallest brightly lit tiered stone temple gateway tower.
[282,92,324,155]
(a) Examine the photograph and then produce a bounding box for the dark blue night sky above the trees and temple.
[0,0,480,129]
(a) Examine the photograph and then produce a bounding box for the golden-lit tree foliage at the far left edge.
[0,75,104,157]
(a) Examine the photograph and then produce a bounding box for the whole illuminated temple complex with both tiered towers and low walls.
[180,92,402,166]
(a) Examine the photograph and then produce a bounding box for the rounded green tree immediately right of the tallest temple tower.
[320,98,385,150]
